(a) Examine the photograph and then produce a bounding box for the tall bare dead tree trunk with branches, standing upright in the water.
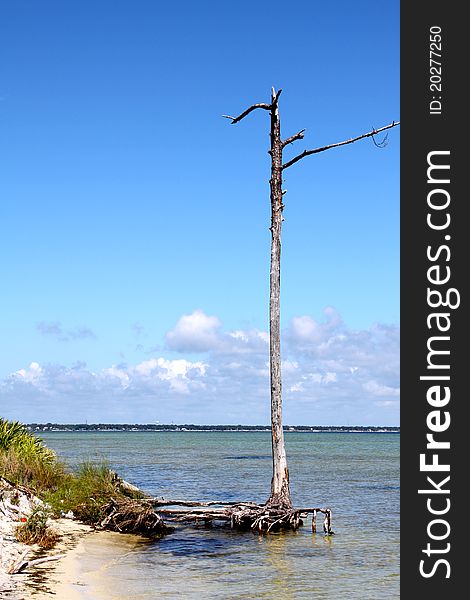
[223,88,399,511]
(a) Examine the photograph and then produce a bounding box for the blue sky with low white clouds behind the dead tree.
[0,0,400,425]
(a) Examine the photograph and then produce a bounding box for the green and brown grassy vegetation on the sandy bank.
[0,419,142,548]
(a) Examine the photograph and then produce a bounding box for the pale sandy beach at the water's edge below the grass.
[0,466,156,600]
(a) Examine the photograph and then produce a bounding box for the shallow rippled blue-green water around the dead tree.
[43,432,399,600]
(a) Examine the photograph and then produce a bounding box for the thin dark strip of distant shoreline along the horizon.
[26,423,400,433]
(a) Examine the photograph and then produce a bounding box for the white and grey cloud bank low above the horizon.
[0,307,399,425]
